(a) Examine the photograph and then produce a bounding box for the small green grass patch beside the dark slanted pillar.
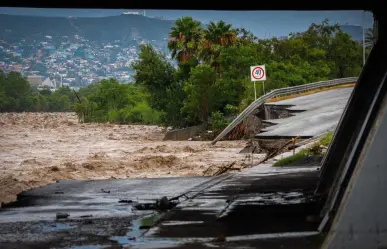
[273,132,333,167]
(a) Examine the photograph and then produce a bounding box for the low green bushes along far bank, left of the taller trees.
[0,71,160,124]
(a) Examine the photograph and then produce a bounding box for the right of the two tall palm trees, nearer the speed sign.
[199,20,237,74]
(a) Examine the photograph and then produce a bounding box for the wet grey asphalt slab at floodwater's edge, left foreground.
[0,176,224,222]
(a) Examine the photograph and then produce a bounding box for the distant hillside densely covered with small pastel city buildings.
[0,31,173,88]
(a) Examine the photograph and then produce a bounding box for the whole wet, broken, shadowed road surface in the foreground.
[0,165,321,249]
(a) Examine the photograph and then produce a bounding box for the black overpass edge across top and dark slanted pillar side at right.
[2,0,387,247]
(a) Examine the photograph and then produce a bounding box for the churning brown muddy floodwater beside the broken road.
[0,113,264,203]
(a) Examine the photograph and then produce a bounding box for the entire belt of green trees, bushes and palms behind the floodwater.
[0,17,372,127]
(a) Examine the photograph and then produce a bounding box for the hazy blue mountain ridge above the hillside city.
[0,14,173,42]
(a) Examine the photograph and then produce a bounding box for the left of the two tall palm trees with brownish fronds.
[168,17,201,62]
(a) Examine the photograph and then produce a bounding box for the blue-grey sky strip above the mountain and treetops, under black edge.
[0,7,373,37]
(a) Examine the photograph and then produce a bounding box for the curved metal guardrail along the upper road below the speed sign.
[211,77,358,144]
